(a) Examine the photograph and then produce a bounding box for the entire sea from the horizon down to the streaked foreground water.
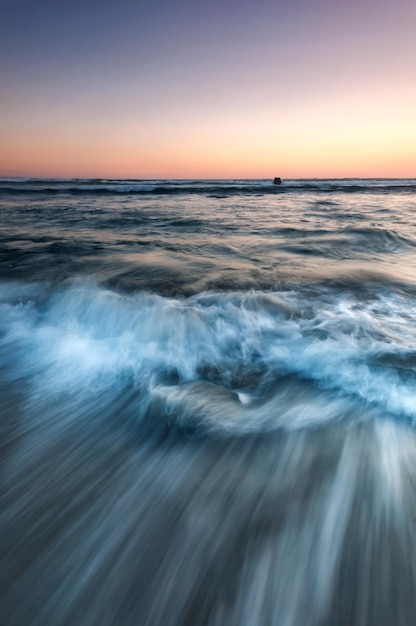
[0,179,416,626]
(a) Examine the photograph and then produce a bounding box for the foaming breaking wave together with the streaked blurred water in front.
[0,280,416,626]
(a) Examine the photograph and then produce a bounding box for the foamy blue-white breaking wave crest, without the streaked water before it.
[0,282,416,434]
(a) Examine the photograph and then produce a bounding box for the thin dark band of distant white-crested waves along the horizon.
[0,179,416,197]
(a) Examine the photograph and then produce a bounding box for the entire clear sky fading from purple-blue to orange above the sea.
[0,0,416,178]
